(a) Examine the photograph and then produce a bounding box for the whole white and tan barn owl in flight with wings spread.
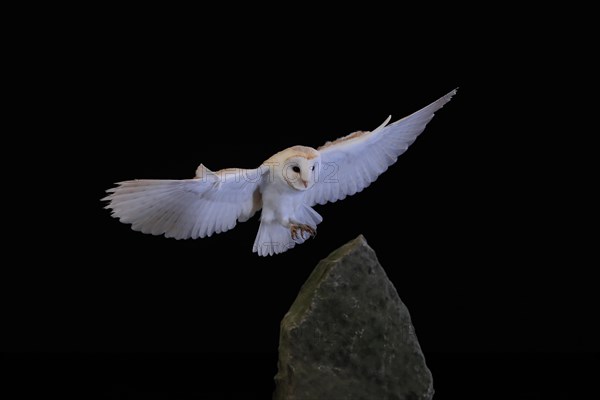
[102,89,456,256]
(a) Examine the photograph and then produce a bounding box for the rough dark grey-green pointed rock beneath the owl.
[273,235,434,400]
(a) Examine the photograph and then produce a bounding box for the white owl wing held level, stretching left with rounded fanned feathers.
[102,165,268,239]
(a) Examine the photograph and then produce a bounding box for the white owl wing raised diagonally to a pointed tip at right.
[304,89,456,206]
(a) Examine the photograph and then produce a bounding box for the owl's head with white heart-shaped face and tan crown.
[278,146,320,191]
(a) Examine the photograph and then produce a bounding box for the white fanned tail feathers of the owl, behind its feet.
[252,205,323,256]
